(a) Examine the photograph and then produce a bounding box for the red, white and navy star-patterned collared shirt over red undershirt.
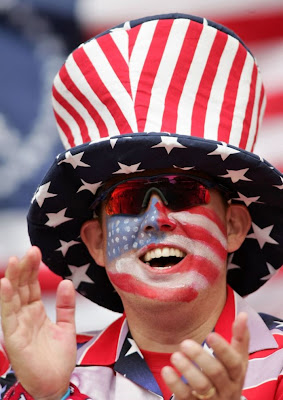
[2,287,283,400]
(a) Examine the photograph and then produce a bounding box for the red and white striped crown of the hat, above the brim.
[53,14,265,151]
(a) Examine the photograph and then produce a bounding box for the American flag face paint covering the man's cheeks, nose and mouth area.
[106,196,227,302]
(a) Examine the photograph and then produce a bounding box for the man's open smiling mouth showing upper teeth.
[141,247,186,269]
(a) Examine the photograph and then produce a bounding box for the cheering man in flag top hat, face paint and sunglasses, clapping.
[1,14,283,400]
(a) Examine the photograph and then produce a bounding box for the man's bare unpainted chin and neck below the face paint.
[124,286,226,353]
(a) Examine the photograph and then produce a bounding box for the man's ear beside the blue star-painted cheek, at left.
[81,219,105,267]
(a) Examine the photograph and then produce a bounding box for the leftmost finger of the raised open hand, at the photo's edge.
[1,277,20,336]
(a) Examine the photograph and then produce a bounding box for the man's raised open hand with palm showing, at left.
[1,247,76,400]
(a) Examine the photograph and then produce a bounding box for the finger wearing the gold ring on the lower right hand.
[171,350,213,394]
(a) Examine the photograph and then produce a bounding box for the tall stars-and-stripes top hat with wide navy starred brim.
[28,14,283,311]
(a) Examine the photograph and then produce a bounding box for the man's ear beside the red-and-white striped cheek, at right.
[226,204,252,253]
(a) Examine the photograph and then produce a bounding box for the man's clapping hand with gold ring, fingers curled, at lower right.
[162,313,249,400]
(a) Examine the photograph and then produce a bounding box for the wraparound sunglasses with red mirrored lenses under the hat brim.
[91,174,232,215]
